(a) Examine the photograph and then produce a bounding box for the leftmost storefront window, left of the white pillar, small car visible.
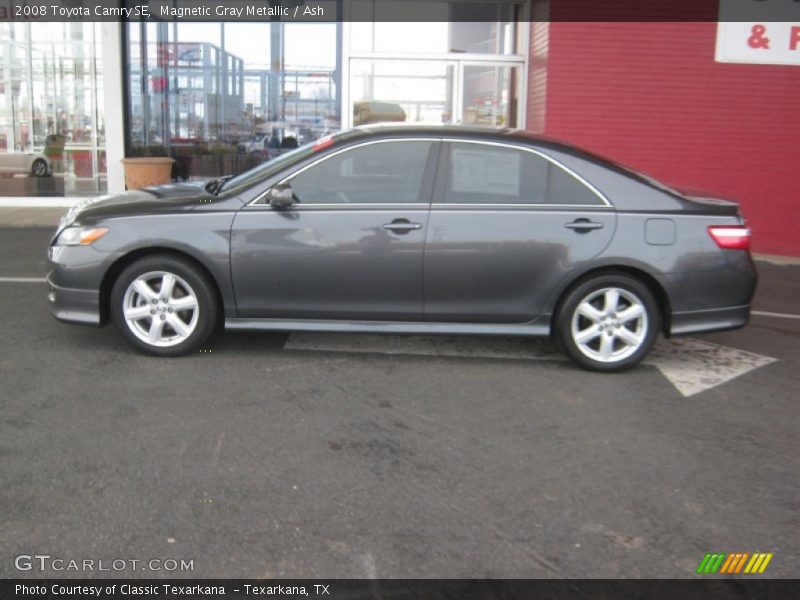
[0,23,106,196]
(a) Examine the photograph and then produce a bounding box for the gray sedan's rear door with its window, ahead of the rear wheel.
[424,142,616,323]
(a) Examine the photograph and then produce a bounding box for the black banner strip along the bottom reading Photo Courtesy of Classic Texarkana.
[0,577,800,600]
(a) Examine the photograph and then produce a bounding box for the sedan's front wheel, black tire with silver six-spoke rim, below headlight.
[111,255,218,356]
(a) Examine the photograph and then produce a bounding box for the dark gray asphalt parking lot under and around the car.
[0,229,800,578]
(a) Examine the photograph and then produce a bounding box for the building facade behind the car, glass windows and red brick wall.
[0,0,800,256]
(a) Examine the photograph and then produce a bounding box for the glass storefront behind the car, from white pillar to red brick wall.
[124,0,527,179]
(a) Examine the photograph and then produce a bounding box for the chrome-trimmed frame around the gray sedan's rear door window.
[431,138,614,210]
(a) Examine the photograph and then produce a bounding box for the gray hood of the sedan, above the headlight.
[63,181,212,225]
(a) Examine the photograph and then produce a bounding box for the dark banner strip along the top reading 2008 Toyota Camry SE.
[0,0,800,23]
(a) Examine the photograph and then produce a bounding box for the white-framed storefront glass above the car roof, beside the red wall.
[346,7,528,127]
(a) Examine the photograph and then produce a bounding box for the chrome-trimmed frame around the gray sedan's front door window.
[245,137,442,210]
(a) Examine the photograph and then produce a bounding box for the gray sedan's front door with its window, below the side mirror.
[231,139,438,321]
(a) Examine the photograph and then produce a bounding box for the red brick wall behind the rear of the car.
[527,22,800,256]
